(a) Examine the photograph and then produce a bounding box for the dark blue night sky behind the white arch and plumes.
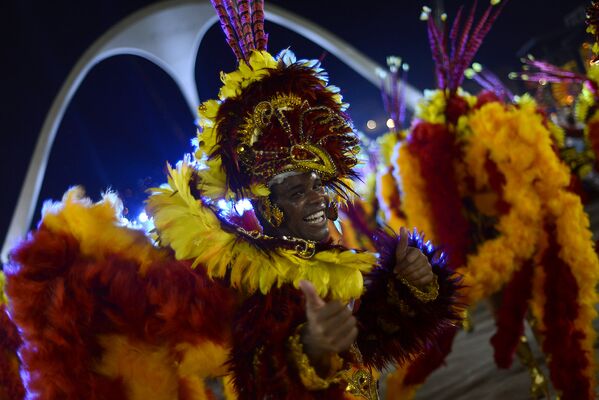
[0,0,587,250]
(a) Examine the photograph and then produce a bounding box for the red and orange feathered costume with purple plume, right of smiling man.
[382,1,599,400]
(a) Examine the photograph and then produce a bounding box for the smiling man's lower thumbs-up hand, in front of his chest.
[300,281,358,371]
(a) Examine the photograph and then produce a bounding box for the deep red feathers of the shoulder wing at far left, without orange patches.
[6,226,235,399]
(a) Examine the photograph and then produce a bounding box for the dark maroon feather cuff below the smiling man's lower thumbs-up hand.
[229,285,346,400]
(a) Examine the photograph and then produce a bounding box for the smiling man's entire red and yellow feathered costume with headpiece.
[1,0,459,399]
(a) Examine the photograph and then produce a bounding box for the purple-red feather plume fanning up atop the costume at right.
[421,0,506,93]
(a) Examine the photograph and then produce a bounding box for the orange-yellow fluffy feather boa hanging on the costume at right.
[461,103,599,387]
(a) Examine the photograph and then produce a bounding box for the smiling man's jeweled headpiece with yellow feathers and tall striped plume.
[195,0,359,203]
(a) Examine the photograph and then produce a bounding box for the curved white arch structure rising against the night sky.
[1,0,421,262]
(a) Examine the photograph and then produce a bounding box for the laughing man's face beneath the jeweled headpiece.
[270,172,329,242]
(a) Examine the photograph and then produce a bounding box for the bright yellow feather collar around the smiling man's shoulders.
[148,160,377,300]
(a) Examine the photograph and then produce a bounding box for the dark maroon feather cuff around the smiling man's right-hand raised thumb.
[356,228,463,368]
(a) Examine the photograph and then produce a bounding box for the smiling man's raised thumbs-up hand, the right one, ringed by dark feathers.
[393,227,434,288]
